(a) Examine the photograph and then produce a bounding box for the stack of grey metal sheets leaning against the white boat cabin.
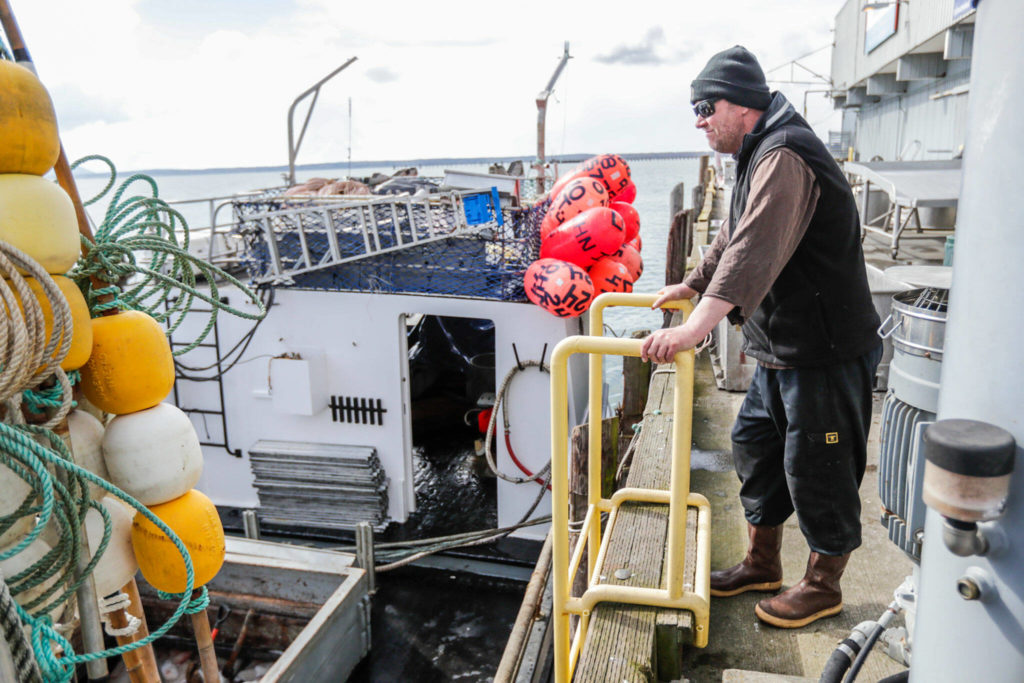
[249,440,387,530]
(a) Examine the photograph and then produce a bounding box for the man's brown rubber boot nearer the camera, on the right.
[754,553,850,629]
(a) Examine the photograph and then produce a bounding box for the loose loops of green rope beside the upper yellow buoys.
[68,155,266,355]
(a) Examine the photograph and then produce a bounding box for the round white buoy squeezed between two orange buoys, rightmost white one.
[102,403,203,505]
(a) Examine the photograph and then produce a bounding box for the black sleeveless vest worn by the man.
[729,93,881,367]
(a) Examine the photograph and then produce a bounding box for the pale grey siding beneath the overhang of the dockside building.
[855,60,971,161]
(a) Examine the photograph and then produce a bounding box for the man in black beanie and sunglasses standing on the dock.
[643,45,882,628]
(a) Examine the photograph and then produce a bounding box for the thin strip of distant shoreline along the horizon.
[78,152,710,176]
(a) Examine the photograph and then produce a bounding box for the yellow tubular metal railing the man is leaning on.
[551,294,711,683]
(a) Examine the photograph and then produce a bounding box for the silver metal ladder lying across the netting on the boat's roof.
[237,188,504,284]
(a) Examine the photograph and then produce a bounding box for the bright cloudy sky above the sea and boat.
[11,0,852,169]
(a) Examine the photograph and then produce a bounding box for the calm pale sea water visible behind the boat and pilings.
[72,159,698,405]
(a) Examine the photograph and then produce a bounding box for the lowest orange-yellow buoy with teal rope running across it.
[131,488,224,593]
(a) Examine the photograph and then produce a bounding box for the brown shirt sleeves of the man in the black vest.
[683,147,820,319]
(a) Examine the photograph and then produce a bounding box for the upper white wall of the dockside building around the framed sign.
[831,0,954,90]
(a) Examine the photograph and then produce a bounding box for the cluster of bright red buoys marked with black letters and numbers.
[523,155,643,317]
